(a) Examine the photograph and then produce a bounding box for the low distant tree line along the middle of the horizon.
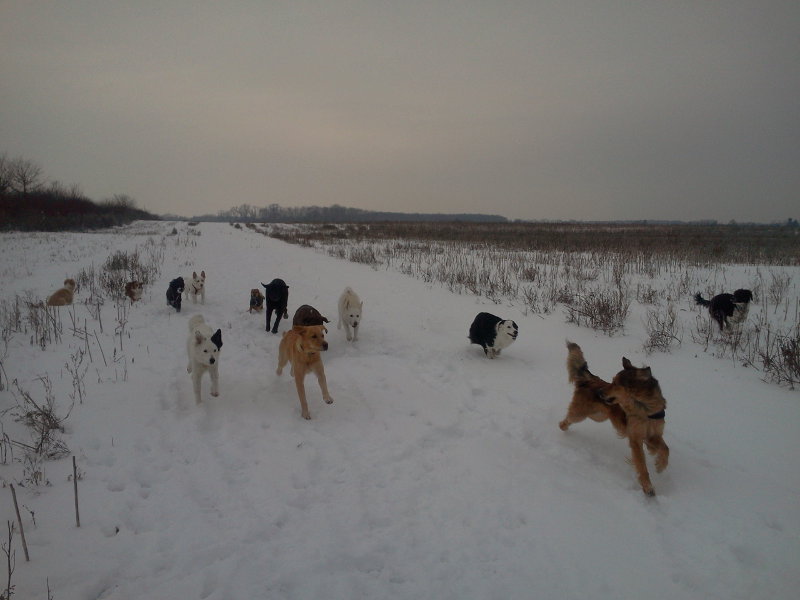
[203,204,508,223]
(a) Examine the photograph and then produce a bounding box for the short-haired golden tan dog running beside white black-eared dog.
[276,325,333,419]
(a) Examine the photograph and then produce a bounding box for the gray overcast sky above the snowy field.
[0,0,800,222]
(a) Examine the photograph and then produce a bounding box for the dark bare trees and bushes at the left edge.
[0,154,158,231]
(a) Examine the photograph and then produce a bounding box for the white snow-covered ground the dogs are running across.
[0,223,800,600]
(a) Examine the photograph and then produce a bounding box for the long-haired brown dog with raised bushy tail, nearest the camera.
[558,342,669,496]
